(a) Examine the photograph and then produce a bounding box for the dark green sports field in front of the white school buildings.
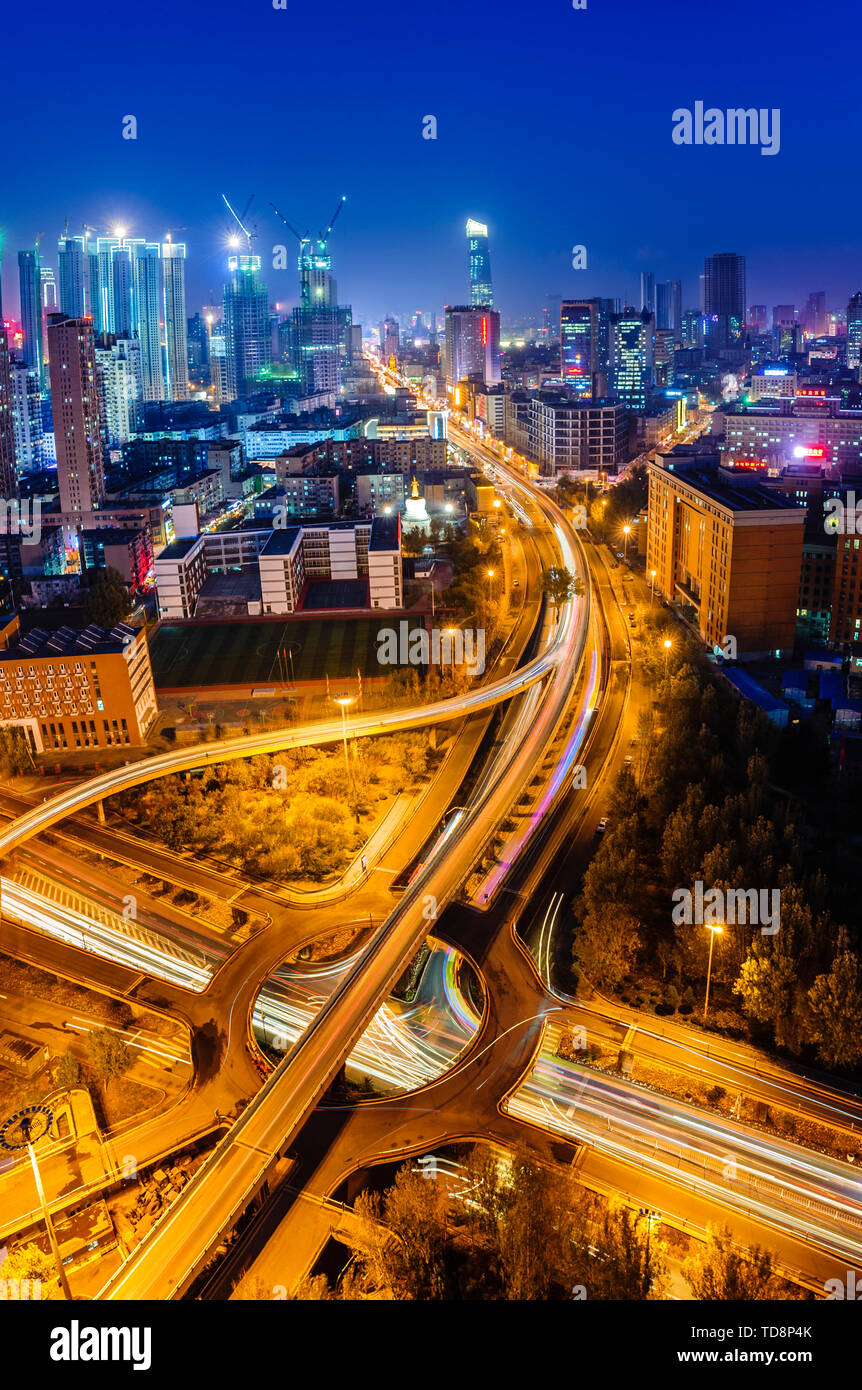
[150,617,420,689]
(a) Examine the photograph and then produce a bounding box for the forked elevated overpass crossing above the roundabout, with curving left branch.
[94,450,589,1300]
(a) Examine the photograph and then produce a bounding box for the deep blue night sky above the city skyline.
[0,0,862,321]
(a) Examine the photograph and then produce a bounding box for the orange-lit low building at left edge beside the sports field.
[0,619,158,753]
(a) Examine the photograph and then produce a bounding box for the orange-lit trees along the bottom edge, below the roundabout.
[238,1145,792,1301]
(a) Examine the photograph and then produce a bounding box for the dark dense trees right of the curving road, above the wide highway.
[574,614,862,1069]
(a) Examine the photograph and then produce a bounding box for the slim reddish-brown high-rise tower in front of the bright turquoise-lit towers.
[47,314,104,513]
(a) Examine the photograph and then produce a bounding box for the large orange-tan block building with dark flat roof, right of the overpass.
[647,446,805,660]
